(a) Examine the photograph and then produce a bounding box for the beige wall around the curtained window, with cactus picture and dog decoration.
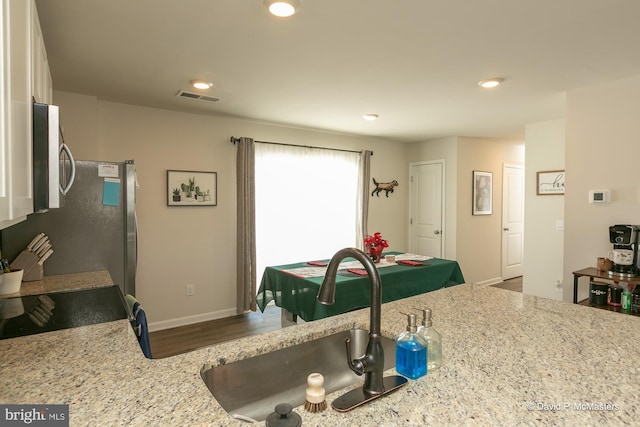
[54,91,408,329]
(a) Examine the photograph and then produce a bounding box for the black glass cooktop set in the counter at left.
[0,285,131,339]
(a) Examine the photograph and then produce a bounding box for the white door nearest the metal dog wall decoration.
[409,160,444,258]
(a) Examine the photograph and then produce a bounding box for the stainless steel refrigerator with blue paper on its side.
[2,160,137,296]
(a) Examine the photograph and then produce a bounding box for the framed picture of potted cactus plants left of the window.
[167,170,218,206]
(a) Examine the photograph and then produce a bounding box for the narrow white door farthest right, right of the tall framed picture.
[502,165,524,280]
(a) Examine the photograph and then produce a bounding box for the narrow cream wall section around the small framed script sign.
[523,119,565,300]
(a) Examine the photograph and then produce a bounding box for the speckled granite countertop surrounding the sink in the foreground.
[0,285,640,427]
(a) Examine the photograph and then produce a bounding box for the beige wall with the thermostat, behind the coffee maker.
[564,76,640,301]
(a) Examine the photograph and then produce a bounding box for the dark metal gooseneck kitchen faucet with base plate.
[318,248,407,412]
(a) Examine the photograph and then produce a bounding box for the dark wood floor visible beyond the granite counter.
[149,277,522,359]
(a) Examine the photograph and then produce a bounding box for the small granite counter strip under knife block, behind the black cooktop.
[2,270,113,298]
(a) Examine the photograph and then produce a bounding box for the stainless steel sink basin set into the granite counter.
[201,329,396,421]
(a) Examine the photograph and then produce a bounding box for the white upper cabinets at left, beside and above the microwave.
[0,0,53,229]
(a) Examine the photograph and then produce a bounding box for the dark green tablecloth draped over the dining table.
[257,252,464,321]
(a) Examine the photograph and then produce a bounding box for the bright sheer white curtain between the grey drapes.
[255,143,369,278]
